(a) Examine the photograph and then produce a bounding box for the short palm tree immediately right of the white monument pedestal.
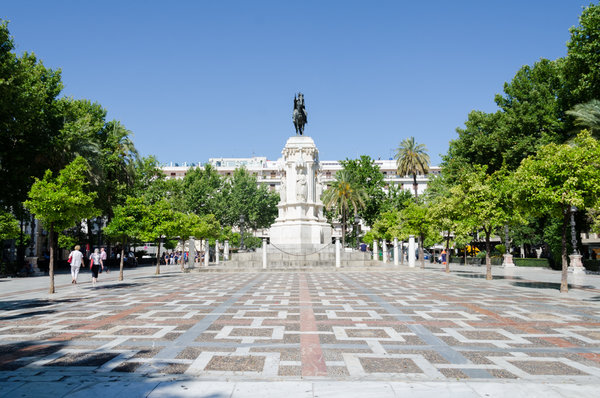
[323,170,367,247]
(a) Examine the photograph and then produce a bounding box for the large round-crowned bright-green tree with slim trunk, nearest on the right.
[513,131,600,292]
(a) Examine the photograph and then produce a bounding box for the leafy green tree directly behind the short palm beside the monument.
[340,155,386,226]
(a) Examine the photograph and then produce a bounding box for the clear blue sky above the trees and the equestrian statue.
[0,0,590,164]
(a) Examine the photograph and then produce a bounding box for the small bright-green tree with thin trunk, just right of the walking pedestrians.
[104,196,147,281]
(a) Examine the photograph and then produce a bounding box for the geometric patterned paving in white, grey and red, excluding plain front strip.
[0,269,600,383]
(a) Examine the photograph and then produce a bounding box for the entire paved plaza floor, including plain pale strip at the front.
[0,266,600,398]
